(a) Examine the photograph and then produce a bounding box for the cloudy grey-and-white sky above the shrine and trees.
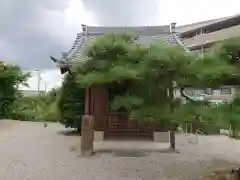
[0,0,240,90]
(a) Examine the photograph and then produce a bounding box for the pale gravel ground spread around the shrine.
[0,121,240,180]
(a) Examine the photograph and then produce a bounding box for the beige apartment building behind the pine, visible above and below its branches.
[176,14,240,99]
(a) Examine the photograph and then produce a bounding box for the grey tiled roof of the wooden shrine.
[62,25,183,62]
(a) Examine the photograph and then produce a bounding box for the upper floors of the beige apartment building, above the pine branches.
[176,14,240,52]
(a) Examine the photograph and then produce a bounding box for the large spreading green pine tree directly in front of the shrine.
[72,34,240,149]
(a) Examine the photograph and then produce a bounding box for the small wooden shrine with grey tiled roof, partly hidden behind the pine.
[51,23,184,141]
